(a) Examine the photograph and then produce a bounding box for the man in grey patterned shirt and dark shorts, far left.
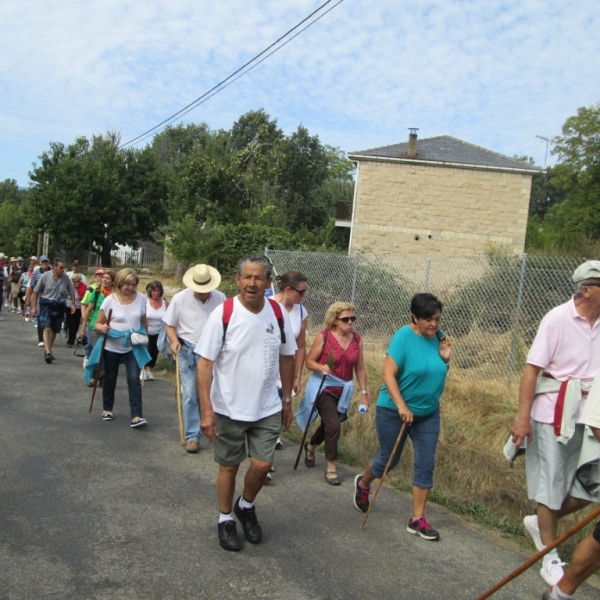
[31,260,75,364]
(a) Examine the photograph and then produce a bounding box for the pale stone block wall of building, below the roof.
[351,161,532,256]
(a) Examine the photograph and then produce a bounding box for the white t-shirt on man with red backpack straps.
[195,297,297,422]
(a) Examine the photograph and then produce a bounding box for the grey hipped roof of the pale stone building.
[348,135,544,175]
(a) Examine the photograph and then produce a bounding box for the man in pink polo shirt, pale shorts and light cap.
[512,260,600,586]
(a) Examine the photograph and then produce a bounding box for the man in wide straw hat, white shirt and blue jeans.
[163,265,225,453]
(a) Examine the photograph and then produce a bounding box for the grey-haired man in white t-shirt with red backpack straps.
[196,255,296,550]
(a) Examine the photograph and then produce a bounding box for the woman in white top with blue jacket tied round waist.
[93,269,150,428]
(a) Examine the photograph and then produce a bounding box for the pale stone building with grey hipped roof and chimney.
[336,129,544,256]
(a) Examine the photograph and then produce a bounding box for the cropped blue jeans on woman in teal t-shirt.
[370,406,440,490]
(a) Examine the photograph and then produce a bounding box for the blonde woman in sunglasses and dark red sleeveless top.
[296,302,369,485]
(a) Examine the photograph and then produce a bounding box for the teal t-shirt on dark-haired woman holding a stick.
[377,325,448,417]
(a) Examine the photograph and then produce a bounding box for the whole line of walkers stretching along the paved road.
[3,248,600,600]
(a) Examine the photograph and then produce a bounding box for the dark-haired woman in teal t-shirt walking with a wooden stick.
[354,294,451,541]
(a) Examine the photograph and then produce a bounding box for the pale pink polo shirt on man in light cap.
[527,297,600,423]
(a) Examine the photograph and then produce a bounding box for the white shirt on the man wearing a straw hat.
[163,288,225,346]
